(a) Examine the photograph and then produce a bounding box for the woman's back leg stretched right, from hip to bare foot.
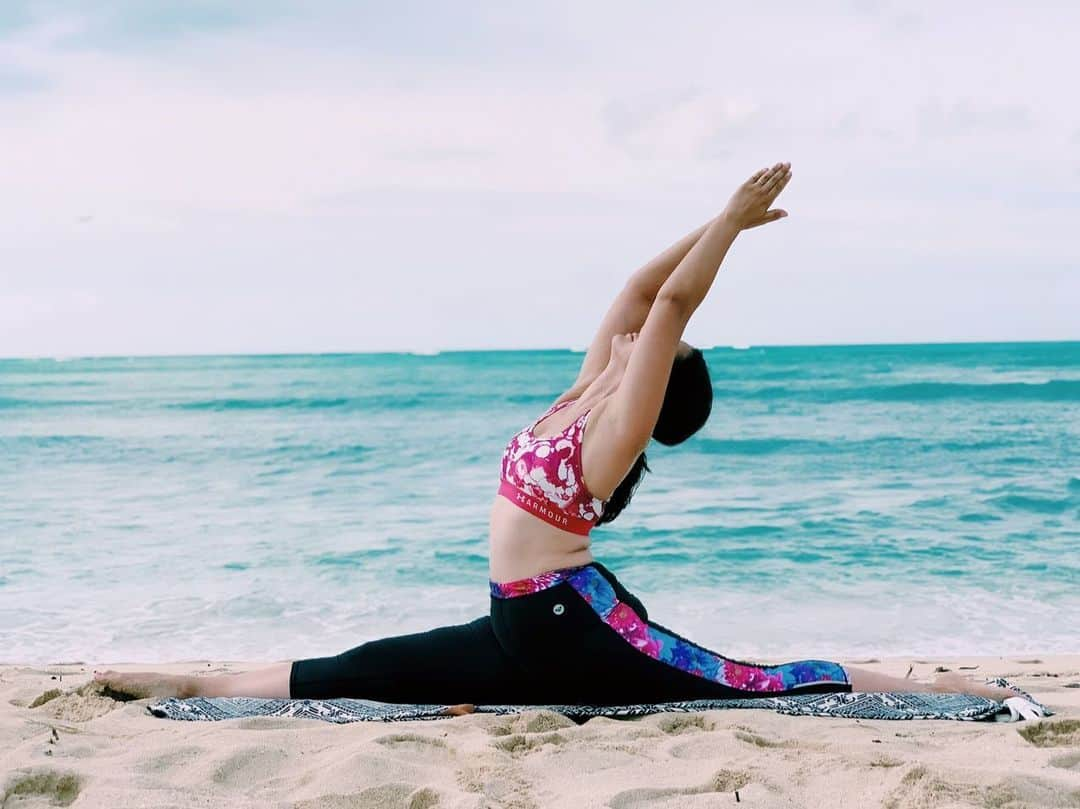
[492,563,1012,704]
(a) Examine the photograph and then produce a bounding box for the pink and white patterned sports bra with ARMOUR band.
[499,399,604,535]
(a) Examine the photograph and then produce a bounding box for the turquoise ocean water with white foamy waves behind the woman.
[0,342,1080,663]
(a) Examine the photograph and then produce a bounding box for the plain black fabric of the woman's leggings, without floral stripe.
[288,562,851,705]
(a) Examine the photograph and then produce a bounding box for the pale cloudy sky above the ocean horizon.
[0,0,1080,356]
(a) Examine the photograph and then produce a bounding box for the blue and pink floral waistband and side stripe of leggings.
[490,565,849,691]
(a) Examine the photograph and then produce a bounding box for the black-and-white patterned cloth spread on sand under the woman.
[147,678,1053,724]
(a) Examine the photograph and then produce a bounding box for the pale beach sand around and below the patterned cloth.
[0,655,1080,809]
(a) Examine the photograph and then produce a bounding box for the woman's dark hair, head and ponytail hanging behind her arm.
[596,349,713,525]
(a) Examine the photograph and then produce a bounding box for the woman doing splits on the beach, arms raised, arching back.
[95,163,1014,710]
